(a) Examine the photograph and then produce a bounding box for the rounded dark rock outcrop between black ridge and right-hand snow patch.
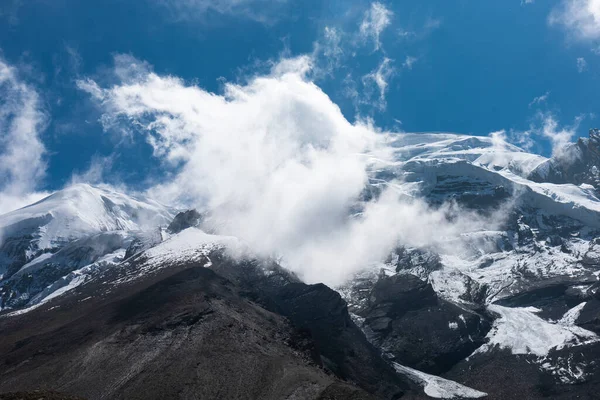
[361,275,491,374]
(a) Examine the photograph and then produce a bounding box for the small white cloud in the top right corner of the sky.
[549,0,600,40]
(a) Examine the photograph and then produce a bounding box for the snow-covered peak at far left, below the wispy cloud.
[0,184,174,308]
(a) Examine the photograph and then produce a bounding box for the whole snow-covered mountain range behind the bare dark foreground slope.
[0,130,600,399]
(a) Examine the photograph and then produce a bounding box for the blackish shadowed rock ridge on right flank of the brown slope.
[207,255,409,398]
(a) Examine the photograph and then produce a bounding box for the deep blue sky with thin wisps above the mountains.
[0,0,600,211]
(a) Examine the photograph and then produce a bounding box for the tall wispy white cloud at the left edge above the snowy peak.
[0,59,47,214]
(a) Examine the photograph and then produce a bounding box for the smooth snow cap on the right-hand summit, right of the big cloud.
[386,133,600,227]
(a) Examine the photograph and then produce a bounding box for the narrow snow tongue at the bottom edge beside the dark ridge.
[392,363,487,399]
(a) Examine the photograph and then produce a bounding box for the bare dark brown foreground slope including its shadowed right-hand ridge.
[0,253,410,399]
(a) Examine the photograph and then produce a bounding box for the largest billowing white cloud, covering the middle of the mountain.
[80,58,502,285]
